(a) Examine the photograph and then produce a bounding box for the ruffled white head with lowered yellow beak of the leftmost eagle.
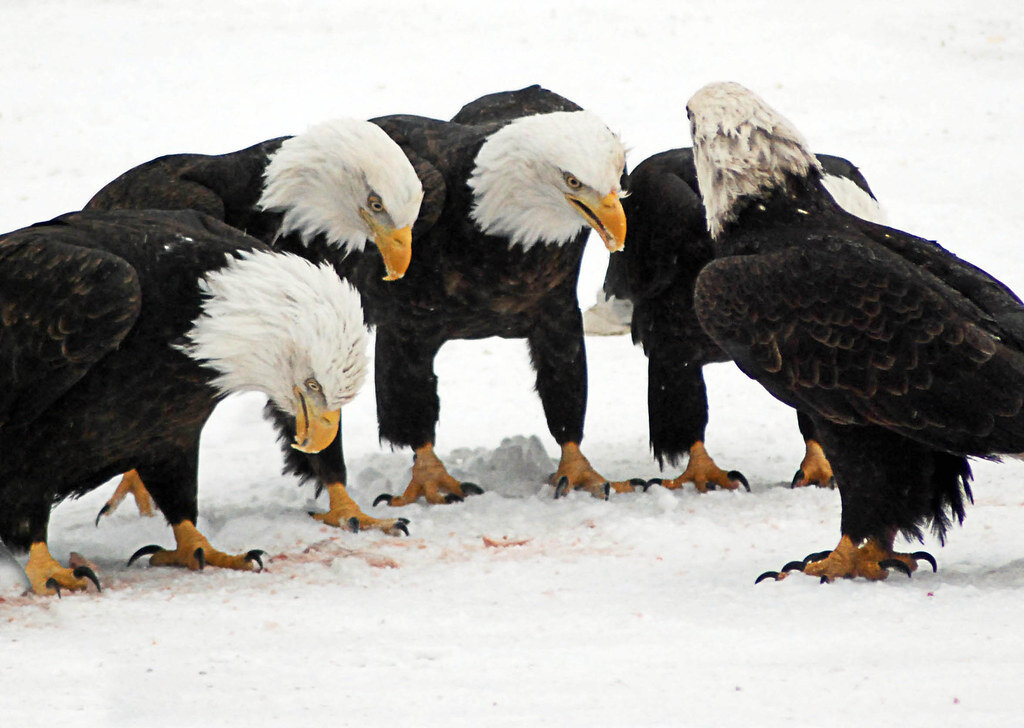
[179,251,367,453]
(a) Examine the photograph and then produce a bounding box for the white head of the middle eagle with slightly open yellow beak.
[469,112,626,251]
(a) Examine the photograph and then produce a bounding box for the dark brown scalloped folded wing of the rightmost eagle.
[695,239,1024,455]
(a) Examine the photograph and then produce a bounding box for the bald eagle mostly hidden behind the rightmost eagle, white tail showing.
[604,148,881,493]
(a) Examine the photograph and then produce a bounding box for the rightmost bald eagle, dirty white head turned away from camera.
[687,83,1024,581]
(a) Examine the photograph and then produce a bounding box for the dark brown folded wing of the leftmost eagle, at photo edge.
[0,232,141,425]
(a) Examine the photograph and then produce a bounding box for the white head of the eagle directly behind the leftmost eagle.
[259,119,423,281]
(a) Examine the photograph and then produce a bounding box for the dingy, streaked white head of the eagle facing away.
[686,82,821,238]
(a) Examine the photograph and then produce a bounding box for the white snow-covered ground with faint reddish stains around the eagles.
[0,0,1024,726]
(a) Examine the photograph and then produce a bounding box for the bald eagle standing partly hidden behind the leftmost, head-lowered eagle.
[85,119,423,533]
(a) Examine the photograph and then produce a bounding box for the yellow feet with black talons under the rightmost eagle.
[755,534,937,584]
